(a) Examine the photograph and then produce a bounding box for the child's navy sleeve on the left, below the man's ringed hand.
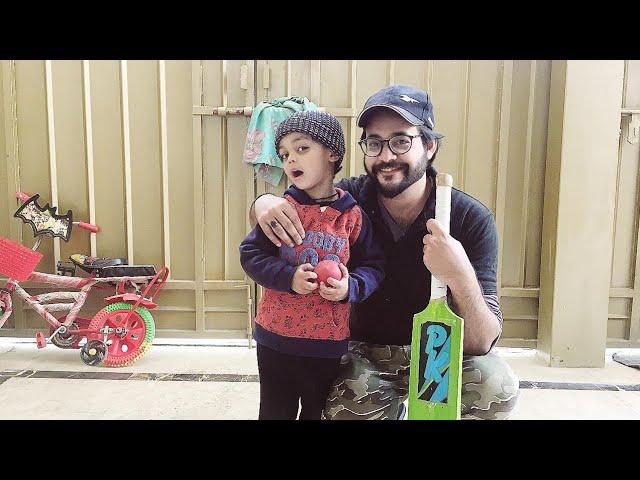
[240,225,296,293]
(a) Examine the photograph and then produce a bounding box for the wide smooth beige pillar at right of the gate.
[538,60,624,367]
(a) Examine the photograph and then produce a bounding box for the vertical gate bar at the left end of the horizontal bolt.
[191,61,205,334]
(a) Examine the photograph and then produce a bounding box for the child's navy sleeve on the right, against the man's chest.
[343,207,385,303]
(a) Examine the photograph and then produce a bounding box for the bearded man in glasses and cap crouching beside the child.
[250,85,519,420]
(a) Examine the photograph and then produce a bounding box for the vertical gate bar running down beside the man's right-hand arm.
[495,60,513,289]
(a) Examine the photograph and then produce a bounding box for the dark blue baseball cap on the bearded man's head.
[358,85,444,138]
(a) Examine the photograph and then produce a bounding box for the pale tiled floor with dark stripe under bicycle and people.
[0,338,640,420]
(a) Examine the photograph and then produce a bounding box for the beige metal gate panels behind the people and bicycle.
[0,60,640,352]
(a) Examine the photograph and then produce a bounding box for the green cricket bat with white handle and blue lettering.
[408,173,464,420]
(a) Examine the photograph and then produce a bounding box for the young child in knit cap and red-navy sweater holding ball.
[240,111,384,420]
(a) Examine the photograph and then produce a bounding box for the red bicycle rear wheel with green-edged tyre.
[89,302,156,367]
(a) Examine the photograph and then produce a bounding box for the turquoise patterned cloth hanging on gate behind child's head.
[242,97,318,187]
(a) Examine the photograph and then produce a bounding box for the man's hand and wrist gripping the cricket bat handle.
[422,218,477,291]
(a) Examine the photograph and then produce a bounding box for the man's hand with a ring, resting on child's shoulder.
[254,195,304,247]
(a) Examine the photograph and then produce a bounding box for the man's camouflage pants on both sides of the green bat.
[323,342,519,420]
